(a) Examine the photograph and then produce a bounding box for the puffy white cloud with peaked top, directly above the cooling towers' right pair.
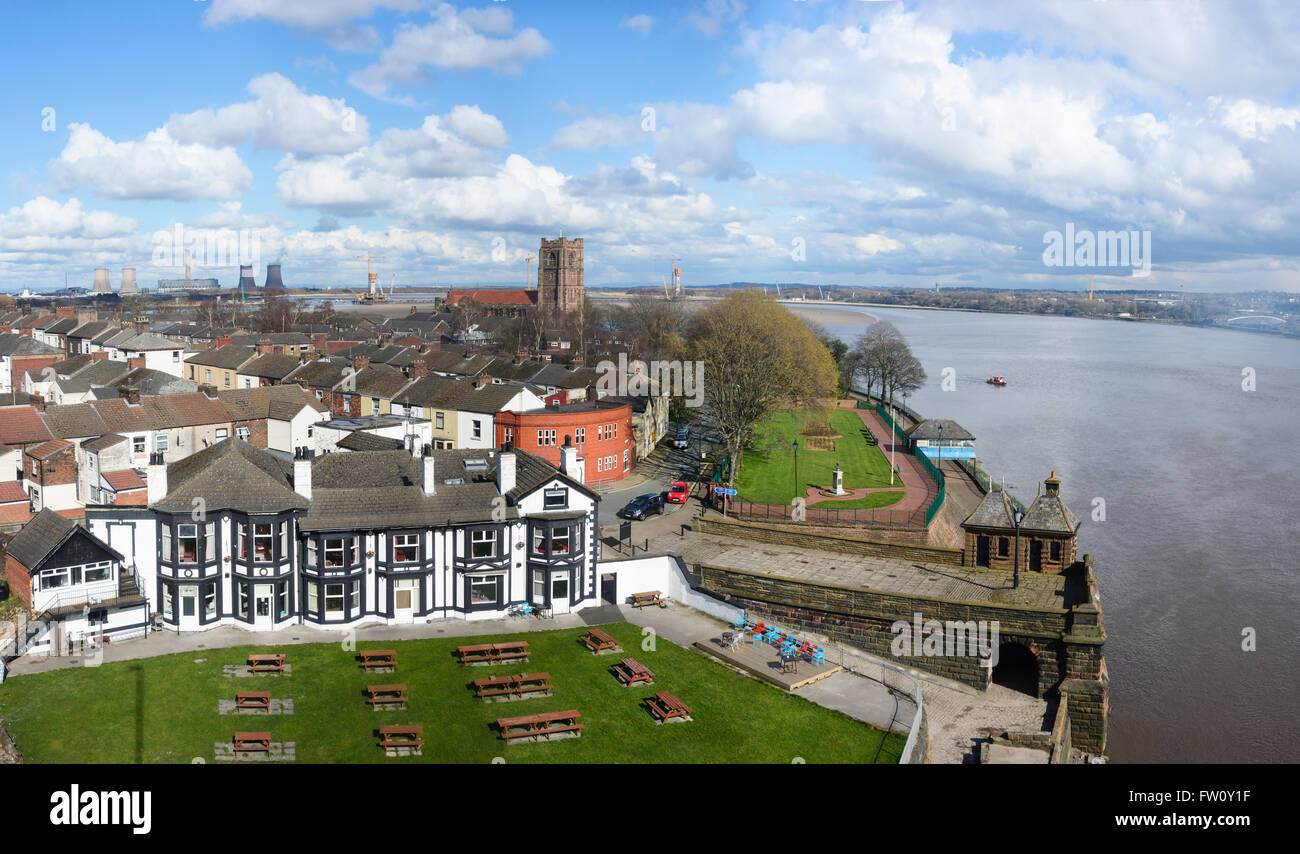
[164,74,371,155]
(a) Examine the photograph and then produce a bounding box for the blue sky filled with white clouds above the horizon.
[0,0,1300,291]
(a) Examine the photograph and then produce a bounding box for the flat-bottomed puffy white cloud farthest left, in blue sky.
[49,122,252,200]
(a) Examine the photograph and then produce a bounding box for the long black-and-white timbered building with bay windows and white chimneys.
[86,438,599,630]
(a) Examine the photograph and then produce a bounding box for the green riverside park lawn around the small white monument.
[736,409,902,501]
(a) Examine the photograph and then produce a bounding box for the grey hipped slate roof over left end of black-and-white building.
[153,438,307,513]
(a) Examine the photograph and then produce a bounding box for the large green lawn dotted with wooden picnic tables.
[0,623,905,764]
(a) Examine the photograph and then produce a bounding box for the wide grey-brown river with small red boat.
[823,307,1300,762]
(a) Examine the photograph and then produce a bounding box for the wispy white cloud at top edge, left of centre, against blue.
[348,3,551,100]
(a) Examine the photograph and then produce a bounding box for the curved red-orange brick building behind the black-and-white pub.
[494,400,637,486]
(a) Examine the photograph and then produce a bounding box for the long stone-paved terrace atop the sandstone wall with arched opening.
[644,530,1069,610]
